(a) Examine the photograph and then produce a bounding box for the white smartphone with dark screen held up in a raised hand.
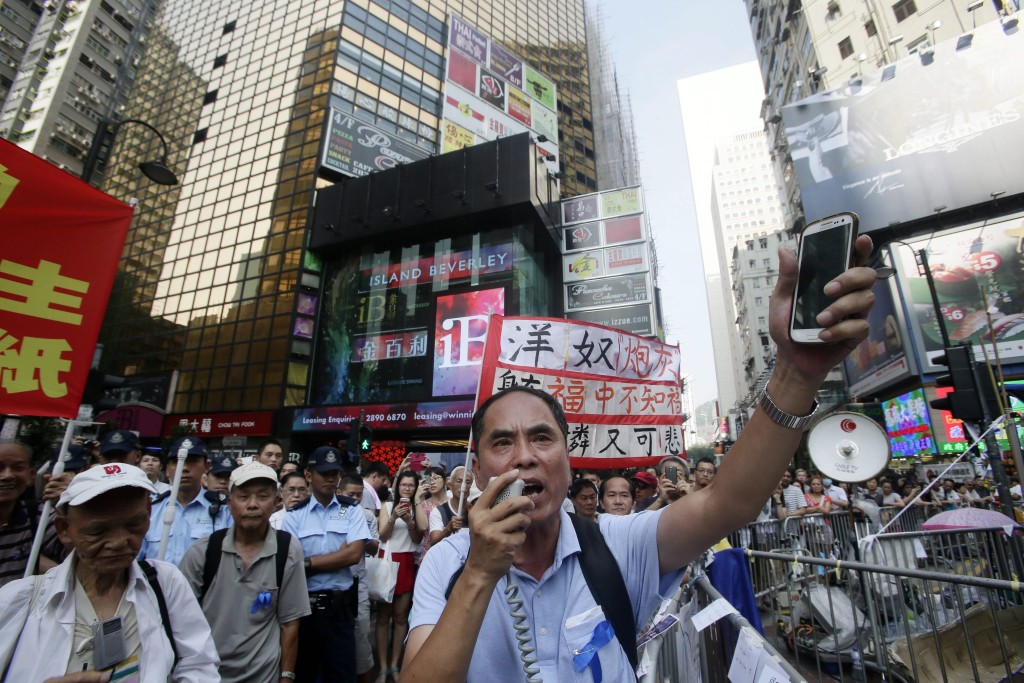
[790,213,857,344]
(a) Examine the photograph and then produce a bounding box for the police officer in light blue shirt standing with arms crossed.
[282,446,370,683]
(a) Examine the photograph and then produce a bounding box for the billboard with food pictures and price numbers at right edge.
[894,216,1024,374]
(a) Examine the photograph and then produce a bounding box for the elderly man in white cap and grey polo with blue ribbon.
[180,463,310,683]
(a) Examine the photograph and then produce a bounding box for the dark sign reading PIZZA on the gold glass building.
[321,108,430,177]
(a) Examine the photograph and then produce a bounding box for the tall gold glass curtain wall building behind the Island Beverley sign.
[101,0,597,413]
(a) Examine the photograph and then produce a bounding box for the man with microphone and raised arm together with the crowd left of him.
[0,236,892,683]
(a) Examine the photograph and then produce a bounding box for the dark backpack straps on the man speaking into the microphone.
[444,513,639,672]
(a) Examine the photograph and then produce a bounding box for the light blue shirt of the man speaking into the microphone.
[409,510,680,683]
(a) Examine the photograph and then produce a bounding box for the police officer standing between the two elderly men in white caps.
[140,436,232,564]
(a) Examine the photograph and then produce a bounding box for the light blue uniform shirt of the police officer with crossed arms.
[281,496,370,593]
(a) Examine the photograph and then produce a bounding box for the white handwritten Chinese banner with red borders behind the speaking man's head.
[477,315,685,468]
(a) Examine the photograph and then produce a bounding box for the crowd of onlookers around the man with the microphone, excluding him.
[0,423,1021,683]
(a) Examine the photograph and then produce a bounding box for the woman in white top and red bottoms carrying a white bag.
[376,470,423,683]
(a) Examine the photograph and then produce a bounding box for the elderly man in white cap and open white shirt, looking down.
[0,463,220,683]
